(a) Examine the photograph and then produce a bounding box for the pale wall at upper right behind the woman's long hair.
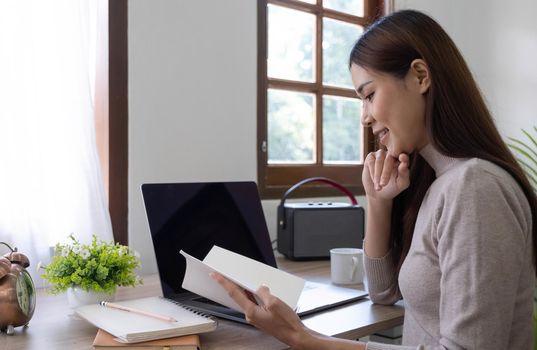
[395,0,537,137]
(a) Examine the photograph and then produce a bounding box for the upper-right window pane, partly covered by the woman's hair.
[323,18,363,88]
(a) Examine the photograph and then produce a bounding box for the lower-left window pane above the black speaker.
[267,89,315,164]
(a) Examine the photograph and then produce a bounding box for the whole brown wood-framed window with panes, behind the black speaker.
[257,0,382,198]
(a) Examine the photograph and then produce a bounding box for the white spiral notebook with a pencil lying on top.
[75,297,217,343]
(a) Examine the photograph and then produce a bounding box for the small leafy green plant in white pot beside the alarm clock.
[40,234,142,308]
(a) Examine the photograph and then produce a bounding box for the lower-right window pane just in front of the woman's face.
[323,96,362,164]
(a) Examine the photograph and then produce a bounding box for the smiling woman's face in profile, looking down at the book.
[351,60,430,158]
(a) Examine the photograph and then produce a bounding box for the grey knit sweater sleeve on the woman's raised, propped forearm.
[364,247,401,305]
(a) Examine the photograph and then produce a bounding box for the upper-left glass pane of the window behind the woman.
[267,5,315,82]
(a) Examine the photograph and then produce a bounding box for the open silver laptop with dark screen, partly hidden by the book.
[142,181,367,323]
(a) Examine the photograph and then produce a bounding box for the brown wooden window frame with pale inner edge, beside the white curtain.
[95,0,129,245]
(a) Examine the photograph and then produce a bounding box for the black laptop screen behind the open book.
[142,182,276,297]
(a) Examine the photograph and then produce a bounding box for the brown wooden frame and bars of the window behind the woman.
[257,0,387,198]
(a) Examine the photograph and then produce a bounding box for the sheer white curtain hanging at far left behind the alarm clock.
[0,0,112,285]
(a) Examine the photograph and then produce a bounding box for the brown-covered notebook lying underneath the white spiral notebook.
[93,329,200,350]
